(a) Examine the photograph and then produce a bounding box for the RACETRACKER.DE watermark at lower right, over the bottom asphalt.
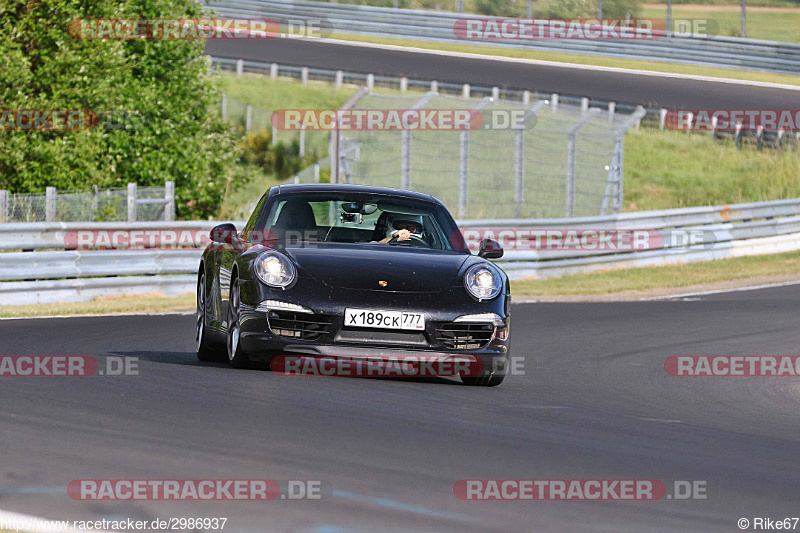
[453,479,708,502]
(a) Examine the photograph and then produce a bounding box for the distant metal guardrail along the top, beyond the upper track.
[209,0,800,74]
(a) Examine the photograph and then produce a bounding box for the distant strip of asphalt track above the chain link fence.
[206,39,800,109]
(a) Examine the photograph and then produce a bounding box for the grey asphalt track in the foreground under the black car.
[0,285,800,533]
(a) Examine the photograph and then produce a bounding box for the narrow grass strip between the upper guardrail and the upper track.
[324,32,800,89]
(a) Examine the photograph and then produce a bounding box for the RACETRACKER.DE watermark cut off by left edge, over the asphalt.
[0,355,139,378]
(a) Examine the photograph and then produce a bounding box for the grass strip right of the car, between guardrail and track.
[511,252,800,297]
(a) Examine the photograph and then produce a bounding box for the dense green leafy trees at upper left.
[0,0,241,218]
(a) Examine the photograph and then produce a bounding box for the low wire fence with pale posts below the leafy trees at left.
[0,181,175,222]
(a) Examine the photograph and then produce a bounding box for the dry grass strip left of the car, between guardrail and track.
[0,293,195,318]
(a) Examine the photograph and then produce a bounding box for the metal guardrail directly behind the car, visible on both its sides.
[0,199,800,305]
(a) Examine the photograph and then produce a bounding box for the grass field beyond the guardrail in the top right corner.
[643,2,800,43]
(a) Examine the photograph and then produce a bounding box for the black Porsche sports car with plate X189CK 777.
[196,184,510,386]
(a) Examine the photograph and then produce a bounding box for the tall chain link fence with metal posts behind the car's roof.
[322,92,645,219]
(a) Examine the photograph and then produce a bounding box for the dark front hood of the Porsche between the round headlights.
[285,244,470,292]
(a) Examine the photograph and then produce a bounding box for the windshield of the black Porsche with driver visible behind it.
[257,193,467,252]
